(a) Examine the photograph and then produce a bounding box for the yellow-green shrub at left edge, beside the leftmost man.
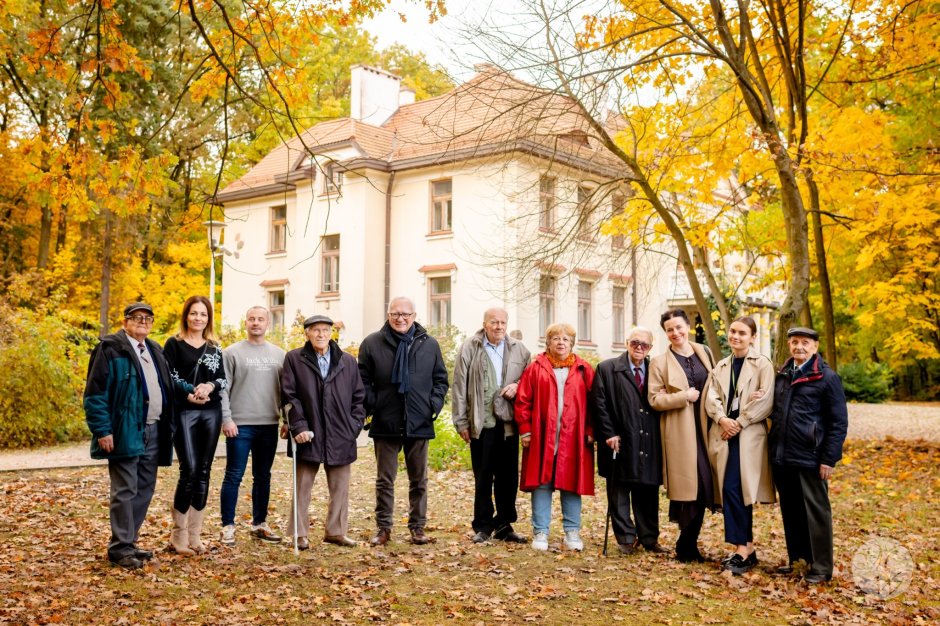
[0,302,97,448]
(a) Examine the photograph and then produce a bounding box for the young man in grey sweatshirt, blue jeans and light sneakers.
[220,306,286,545]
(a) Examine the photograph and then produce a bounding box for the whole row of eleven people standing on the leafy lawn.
[84,296,847,583]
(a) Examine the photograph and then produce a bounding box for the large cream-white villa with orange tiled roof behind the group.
[216,66,770,358]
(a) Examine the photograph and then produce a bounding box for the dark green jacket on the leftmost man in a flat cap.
[84,330,175,465]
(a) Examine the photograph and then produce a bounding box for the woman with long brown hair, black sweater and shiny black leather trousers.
[163,296,227,555]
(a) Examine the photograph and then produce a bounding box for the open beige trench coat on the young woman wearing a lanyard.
[705,349,775,506]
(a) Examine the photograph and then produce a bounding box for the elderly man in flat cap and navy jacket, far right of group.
[768,327,849,584]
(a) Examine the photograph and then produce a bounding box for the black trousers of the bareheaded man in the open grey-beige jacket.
[470,424,519,538]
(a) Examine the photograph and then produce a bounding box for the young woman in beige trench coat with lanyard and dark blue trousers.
[705,317,774,575]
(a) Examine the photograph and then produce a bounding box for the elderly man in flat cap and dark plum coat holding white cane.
[281,315,366,550]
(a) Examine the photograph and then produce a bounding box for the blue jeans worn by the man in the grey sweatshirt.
[220,424,278,526]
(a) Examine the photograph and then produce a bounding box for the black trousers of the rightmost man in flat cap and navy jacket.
[773,465,833,577]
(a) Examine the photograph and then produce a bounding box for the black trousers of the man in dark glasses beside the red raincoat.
[607,480,659,546]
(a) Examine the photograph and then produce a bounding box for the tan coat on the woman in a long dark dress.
[647,341,712,502]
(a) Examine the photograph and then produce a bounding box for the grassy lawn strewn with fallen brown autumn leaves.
[0,441,940,626]
